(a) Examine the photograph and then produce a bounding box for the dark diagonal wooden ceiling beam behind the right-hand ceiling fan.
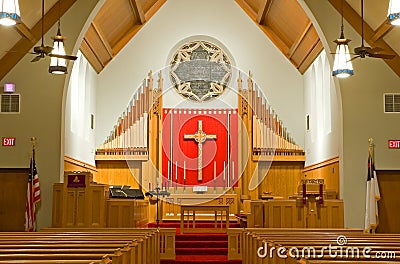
[328,0,400,76]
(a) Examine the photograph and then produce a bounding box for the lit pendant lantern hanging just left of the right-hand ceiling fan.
[332,0,354,78]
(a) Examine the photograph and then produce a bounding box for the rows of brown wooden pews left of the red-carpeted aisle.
[0,232,156,264]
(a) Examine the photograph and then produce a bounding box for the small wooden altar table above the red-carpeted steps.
[180,205,229,234]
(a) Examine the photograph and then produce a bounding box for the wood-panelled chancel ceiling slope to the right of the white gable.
[236,0,323,73]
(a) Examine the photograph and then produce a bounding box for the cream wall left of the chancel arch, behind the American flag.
[0,0,98,228]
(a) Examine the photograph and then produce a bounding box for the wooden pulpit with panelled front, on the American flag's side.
[52,171,149,228]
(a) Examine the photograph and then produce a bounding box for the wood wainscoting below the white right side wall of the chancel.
[303,157,340,199]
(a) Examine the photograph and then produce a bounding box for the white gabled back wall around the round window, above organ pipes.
[96,0,304,146]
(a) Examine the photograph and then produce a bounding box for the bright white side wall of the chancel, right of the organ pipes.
[304,51,341,166]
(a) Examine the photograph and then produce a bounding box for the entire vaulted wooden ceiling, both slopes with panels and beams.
[0,0,400,79]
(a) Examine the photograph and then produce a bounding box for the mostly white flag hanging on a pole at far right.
[365,151,381,232]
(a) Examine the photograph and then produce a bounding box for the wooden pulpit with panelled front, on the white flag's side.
[248,179,344,228]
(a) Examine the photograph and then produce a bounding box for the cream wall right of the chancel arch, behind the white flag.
[301,0,400,228]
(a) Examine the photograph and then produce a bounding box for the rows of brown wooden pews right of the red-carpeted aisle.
[243,229,400,264]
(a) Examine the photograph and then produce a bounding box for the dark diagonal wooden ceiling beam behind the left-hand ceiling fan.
[0,0,77,80]
